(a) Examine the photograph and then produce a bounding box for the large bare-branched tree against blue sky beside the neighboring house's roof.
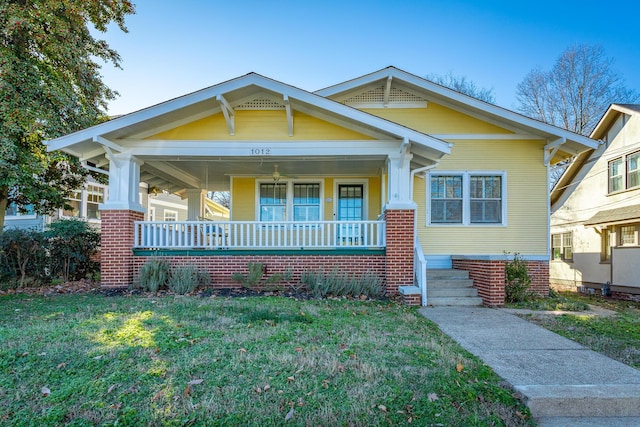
[516,44,639,135]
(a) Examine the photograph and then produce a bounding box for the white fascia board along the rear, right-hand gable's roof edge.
[314,67,598,149]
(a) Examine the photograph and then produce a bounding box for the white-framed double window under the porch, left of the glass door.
[258,181,321,222]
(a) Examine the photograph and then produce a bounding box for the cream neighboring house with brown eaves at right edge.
[549,104,640,300]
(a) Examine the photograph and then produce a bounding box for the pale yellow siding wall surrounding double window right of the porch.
[414,141,548,255]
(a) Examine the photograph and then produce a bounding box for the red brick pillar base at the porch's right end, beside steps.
[384,209,415,296]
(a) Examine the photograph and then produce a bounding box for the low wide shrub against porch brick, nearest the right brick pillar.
[301,268,384,298]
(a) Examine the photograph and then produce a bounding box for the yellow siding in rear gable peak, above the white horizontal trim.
[363,102,512,134]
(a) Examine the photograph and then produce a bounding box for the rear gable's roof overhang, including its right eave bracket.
[315,66,598,158]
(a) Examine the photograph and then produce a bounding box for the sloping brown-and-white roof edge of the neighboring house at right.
[551,104,640,205]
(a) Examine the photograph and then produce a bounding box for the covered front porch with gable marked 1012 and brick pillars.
[49,74,451,302]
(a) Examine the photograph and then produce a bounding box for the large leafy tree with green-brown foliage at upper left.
[0,0,134,232]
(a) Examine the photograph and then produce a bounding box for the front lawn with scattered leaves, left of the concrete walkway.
[0,294,532,426]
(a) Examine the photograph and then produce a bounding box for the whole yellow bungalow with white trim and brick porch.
[49,67,597,305]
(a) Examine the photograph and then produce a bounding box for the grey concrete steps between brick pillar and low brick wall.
[427,269,482,306]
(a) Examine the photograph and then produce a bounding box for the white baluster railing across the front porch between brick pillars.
[134,221,385,249]
